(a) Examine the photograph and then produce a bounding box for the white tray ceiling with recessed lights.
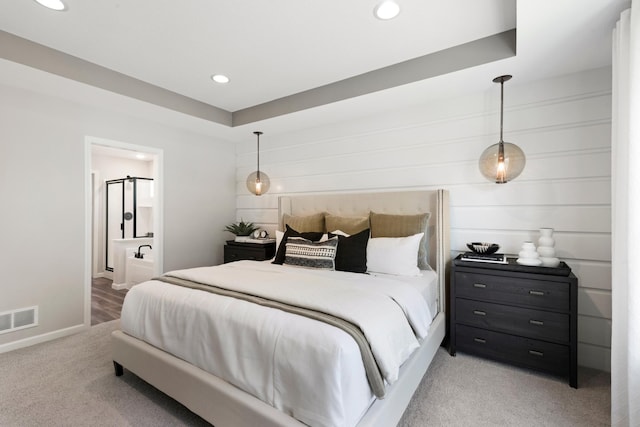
[0,0,630,139]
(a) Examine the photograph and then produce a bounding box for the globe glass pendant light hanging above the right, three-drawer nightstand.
[478,75,526,184]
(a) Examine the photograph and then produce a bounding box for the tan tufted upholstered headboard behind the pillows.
[278,190,451,310]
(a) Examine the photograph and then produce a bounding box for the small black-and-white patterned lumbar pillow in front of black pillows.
[284,237,338,270]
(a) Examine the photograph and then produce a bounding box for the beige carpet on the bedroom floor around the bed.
[0,321,610,427]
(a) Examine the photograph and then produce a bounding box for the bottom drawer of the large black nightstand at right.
[456,325,569,375]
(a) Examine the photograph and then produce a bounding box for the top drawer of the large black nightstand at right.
[455,271,570,311]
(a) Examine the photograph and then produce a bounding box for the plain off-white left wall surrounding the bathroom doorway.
[0,78,235,351]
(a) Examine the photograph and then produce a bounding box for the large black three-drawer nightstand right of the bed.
[449,256,578,388]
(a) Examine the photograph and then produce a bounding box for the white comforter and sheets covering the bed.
[121,261,436,426]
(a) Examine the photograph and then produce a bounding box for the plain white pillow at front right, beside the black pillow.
[367,233,424,276]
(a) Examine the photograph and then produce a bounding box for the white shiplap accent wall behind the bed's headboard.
[237,68,611,371]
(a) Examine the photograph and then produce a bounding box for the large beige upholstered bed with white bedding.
[112,190,450,427]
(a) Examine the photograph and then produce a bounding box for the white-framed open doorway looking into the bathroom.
[85,137,162,325]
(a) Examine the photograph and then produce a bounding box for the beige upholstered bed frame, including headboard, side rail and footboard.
[112,190,450,427]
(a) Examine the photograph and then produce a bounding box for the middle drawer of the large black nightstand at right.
[456,298,569,343]
